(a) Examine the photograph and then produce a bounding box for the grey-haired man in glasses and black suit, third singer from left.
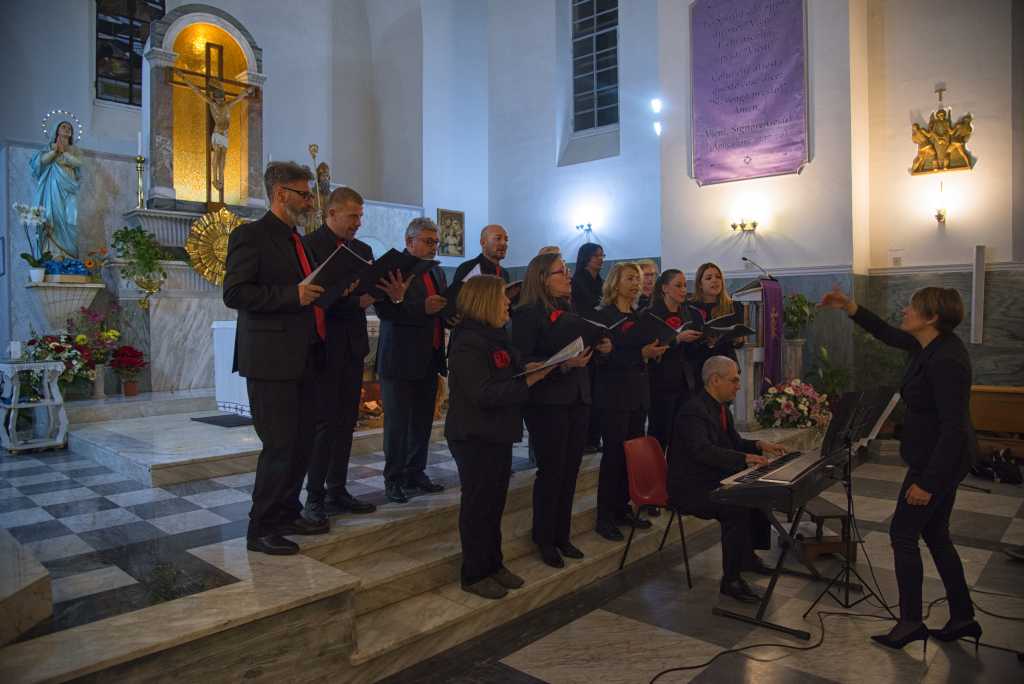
[375,218,447,504]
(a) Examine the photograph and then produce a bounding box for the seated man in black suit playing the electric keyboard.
[668,356,785,603]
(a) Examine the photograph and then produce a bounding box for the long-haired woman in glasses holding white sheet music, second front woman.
[509,253,611,567]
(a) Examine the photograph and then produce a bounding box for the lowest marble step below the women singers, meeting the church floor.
[347,516,712,682]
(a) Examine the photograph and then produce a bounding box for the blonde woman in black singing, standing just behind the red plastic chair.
[594,263,669,541]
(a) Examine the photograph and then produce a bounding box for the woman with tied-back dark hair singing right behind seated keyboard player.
[644,268,701,454]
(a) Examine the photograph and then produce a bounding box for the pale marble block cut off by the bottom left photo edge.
[0,529,53,646]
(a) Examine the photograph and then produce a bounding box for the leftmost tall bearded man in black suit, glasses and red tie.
[223,162,329,555]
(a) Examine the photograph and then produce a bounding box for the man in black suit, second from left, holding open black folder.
[302,187,404,521]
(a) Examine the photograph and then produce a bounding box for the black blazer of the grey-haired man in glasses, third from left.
[374,259,447,380]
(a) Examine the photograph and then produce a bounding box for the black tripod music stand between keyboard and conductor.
[804,387,899,619]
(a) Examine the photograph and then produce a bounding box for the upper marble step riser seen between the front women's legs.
[336,489,597,615]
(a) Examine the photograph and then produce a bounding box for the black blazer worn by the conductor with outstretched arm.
[853,306,978,494]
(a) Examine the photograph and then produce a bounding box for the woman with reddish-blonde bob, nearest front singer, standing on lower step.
[444,275,551,599]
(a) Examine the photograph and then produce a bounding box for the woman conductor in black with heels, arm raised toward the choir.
[820,288,981,648]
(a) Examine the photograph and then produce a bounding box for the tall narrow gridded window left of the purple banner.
[568,0,618,132]
